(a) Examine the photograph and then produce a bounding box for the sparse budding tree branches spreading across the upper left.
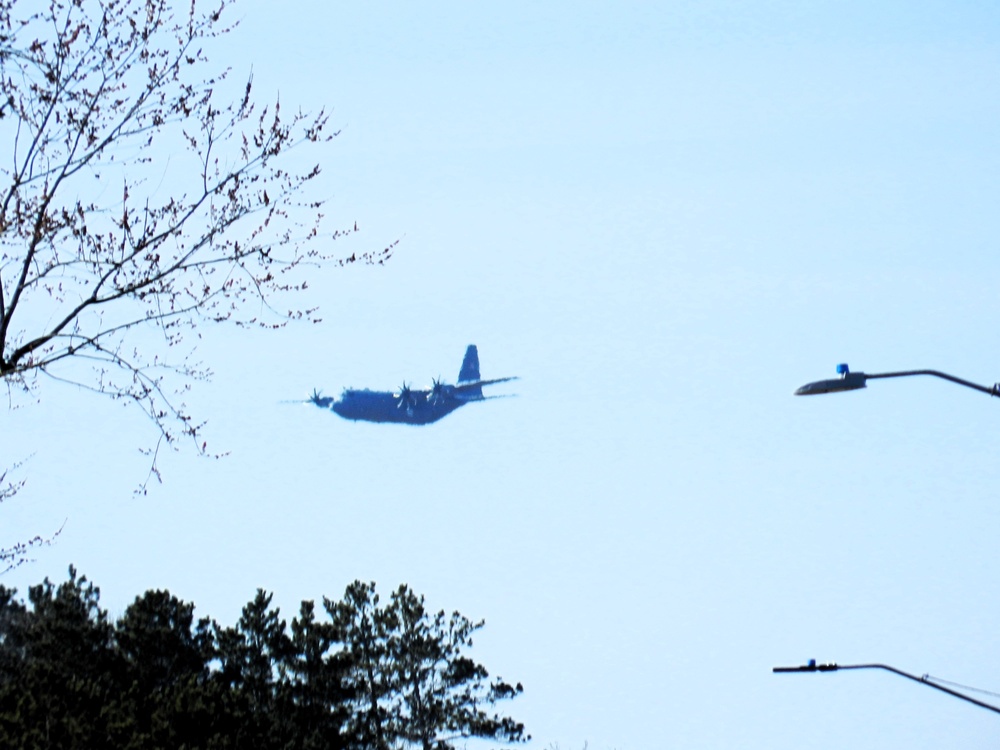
[0,0,394,496]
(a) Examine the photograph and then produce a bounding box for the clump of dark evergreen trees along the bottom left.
[0,569,529,750]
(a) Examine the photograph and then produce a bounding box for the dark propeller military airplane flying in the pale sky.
[309,344,517,425]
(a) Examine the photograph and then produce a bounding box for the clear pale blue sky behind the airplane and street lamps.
[0,0,1000,750]
